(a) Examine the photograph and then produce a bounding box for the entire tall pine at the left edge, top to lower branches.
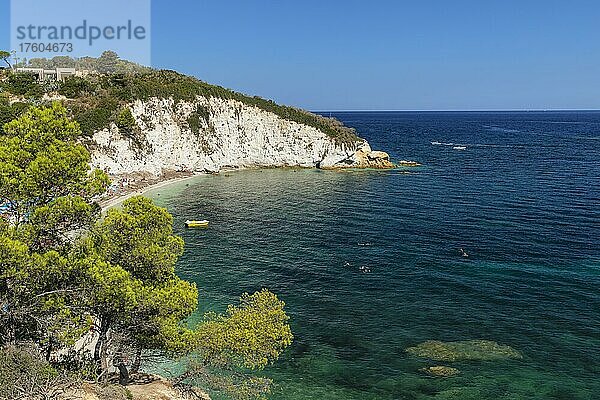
[0,104,108,348]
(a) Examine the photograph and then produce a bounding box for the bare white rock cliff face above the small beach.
[89,97,393,175]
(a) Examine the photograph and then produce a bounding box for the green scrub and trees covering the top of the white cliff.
[0,52,360,147]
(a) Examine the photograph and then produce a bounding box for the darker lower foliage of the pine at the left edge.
[0,232,86,348]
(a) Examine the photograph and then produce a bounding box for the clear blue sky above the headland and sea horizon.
[0,0,600,110]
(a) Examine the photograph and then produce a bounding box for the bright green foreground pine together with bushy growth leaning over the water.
[79,197,292,397]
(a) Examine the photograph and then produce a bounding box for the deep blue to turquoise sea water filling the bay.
[154,112,600,400]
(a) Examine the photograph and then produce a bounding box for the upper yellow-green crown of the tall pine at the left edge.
[0,103,108,250]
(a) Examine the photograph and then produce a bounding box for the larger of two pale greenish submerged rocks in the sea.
[406,340,523,361]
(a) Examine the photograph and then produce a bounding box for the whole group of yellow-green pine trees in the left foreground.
[0,102,292,399]
